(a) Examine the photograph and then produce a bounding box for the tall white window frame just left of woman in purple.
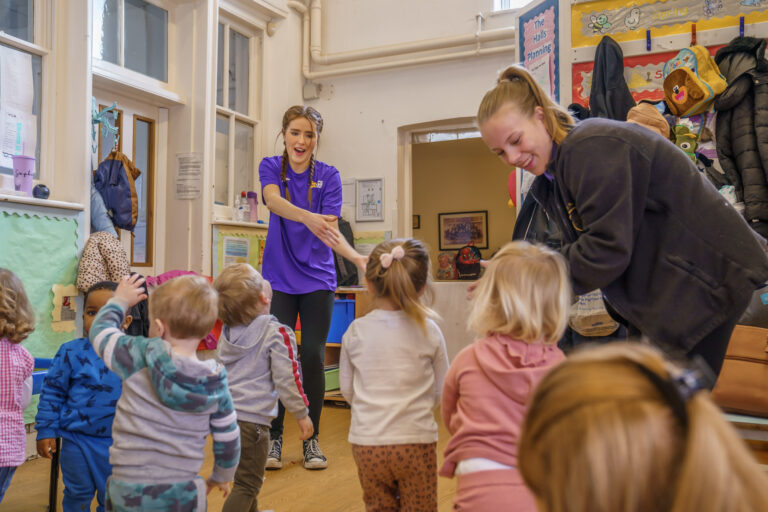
[211,9,264,219]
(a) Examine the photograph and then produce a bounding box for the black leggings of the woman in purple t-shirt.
[269,290,334,439]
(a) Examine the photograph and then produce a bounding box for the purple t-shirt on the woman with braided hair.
[259,156,341,295]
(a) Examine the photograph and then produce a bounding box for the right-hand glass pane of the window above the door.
[125,0,168,82]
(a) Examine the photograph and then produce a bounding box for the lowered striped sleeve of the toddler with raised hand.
[211,377,240,482]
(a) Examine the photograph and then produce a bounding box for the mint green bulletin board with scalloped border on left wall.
[0,210,82,423]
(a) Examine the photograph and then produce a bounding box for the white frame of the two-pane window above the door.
[91,0,176,88]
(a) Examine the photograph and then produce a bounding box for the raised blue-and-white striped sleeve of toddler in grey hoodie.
[88,298,153,379]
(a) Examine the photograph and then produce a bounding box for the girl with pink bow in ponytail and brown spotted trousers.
[339,239,448,511]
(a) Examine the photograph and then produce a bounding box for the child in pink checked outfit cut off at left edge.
[0,268,35,502]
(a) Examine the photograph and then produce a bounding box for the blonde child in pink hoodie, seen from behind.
[440,242,571,512]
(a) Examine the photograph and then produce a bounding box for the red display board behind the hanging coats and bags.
[571,45,724,107]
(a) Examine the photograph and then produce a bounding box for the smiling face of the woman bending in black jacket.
[480,103,552,176]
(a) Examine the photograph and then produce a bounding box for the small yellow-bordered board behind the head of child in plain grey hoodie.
[211,224,267,278]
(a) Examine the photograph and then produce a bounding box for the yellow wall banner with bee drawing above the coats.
[571,0,768,48]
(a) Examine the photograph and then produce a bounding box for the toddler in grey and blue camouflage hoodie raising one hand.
[89,274,240,512]
